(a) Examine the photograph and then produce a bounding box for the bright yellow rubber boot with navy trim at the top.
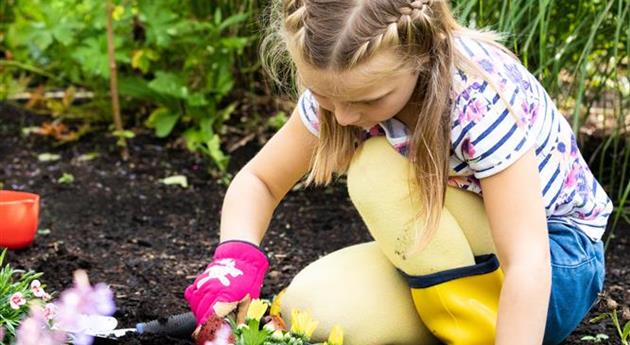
[401,254,503,345]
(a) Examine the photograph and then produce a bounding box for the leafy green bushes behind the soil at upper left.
[0,0,253,169]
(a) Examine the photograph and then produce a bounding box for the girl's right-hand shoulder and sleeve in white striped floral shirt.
[451,37,543,178]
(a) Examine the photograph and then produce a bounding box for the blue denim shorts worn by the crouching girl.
[543,222,605,345]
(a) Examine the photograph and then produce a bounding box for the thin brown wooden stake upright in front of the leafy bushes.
[107,0,129,160]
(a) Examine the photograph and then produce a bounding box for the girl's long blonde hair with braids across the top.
[261,0,520,252]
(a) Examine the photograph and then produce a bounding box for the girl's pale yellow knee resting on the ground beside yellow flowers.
[281,242,440,345]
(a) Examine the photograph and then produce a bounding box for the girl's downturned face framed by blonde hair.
[298,50,419,129]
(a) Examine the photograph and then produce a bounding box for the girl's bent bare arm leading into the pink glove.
[221,108,318,245]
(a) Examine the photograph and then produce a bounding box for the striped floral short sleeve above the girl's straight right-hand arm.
[452,82,538,179]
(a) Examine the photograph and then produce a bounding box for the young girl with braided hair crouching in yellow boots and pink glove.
[185,0,612,345]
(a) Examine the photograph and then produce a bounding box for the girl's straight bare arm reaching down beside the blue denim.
[481,149,551,345]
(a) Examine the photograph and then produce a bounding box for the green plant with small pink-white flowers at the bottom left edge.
[0,249,50,344]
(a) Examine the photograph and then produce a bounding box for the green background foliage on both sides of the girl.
[0,0,630,230]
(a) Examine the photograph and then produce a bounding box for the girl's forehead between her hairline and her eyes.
[297,49,412,100]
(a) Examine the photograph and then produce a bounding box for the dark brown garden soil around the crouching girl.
[0,104,630,344]
